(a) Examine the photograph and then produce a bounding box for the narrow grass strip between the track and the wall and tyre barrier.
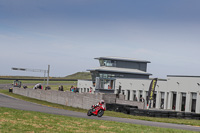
[0,89,200,126]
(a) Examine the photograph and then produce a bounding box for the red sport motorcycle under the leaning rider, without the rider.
[87,105,106,117]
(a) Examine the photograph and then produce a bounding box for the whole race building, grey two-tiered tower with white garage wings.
[77,57,200,113]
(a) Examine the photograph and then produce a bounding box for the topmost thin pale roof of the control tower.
[94,56,151,63]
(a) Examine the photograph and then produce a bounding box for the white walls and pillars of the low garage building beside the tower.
[77,76,200,113]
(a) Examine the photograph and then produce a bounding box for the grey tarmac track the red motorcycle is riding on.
[0,93,200,131]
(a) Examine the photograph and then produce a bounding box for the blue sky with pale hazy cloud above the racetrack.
[0,0,200,78]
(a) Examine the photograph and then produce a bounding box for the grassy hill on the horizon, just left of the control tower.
[65,72,92,79]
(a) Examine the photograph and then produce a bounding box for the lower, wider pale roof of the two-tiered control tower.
[87,66,152,75]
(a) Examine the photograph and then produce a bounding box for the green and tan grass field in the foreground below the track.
[0,107,197,133]
